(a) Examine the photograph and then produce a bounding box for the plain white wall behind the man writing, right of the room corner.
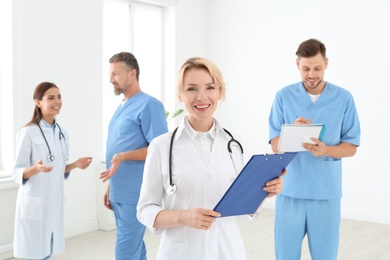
[207,0,390,224]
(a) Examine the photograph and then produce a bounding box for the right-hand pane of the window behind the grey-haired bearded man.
[129,3,176,110]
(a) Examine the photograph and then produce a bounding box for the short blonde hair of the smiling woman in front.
[177,57,226,100]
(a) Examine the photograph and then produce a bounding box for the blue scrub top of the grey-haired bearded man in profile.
[106,92,168,204]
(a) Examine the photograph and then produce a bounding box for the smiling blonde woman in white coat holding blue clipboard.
[137,58,283,260]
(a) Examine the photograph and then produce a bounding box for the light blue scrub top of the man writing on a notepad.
[269,82,360,200]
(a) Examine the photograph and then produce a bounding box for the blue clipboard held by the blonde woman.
[213,152,297,217]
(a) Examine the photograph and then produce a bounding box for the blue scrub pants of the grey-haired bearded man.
[111,202,146,260]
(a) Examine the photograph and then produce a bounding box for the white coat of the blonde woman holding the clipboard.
[137,119,249,260]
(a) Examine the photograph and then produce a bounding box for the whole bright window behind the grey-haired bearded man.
[103,1,176,158]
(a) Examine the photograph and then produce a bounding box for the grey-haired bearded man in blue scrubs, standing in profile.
[100,52,168,260]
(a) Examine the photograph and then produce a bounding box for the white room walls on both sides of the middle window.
[9,0,390,248]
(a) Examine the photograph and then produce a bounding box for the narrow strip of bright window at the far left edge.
[0,0,15,178]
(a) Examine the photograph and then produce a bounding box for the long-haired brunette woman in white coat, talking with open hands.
[13,82,92,259]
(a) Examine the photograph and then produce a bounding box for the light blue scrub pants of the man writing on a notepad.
[275,195,341,260]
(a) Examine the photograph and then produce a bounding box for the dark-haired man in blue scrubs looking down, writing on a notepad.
[269,39,360,260]
